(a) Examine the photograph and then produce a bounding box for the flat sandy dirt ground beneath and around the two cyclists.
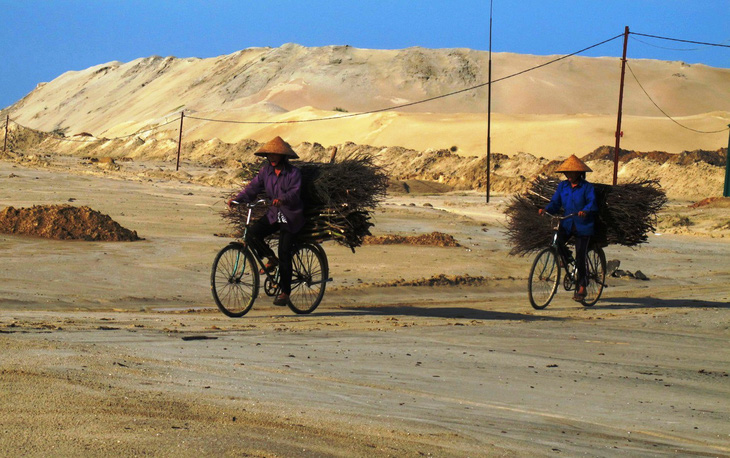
[0,157,730,457]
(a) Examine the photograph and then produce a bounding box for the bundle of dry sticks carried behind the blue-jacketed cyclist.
[505,176,667,256]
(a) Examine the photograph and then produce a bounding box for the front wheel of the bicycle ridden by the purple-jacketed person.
[210,243,259,318]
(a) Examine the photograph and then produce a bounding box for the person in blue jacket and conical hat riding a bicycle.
[539,155,598,302]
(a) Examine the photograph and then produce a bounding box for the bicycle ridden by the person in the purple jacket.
[210,199,331,318]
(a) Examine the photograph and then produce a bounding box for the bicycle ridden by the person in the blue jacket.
[527,213,606,310]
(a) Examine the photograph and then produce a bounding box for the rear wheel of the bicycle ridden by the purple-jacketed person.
[289,243,329,313]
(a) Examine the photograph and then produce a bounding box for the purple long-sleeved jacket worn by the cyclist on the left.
[234,162,304,233]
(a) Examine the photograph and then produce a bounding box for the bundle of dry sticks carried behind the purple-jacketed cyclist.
[222,156,388,251]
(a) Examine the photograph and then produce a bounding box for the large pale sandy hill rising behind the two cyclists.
[2,44,730,158]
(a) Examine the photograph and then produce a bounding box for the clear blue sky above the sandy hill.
[0,0,730,107]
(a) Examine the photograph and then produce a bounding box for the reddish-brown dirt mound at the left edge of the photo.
[0,205,140,242]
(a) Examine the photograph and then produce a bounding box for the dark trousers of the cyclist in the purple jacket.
[246,216,295,294]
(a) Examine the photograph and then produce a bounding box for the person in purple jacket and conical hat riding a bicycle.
[228,137,304,305]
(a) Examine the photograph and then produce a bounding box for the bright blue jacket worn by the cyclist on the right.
[545,180,598,235]
